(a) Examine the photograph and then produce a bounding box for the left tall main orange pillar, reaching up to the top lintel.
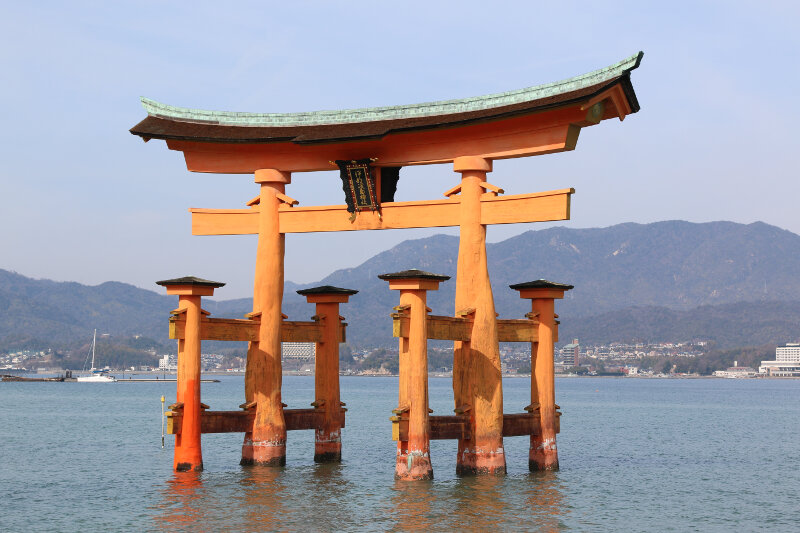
[241,169,291,466]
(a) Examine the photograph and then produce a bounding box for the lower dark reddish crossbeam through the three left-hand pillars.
[167,409,345,435]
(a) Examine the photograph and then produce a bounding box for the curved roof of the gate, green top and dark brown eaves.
[130,52,643,143]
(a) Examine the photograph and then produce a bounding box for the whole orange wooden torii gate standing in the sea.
[130,52,642,477]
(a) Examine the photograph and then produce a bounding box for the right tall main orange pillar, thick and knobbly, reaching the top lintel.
[453,157,506,475]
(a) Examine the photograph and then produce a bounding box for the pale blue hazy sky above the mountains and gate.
[0,1,800,299]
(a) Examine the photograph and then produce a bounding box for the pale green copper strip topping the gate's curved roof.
[142,52,643,127]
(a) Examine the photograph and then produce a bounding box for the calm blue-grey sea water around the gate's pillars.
[0,376,800,531]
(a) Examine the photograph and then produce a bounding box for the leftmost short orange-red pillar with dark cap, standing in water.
[156,276,225,472]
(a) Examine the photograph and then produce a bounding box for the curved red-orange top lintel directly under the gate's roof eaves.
[167,109,580,174]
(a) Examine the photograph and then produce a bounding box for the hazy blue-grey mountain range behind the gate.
[0,221,800,350]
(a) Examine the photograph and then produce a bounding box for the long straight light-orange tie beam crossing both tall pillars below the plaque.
[189,189,575,235]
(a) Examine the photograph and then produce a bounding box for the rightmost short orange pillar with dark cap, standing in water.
[511,279,573,472]
